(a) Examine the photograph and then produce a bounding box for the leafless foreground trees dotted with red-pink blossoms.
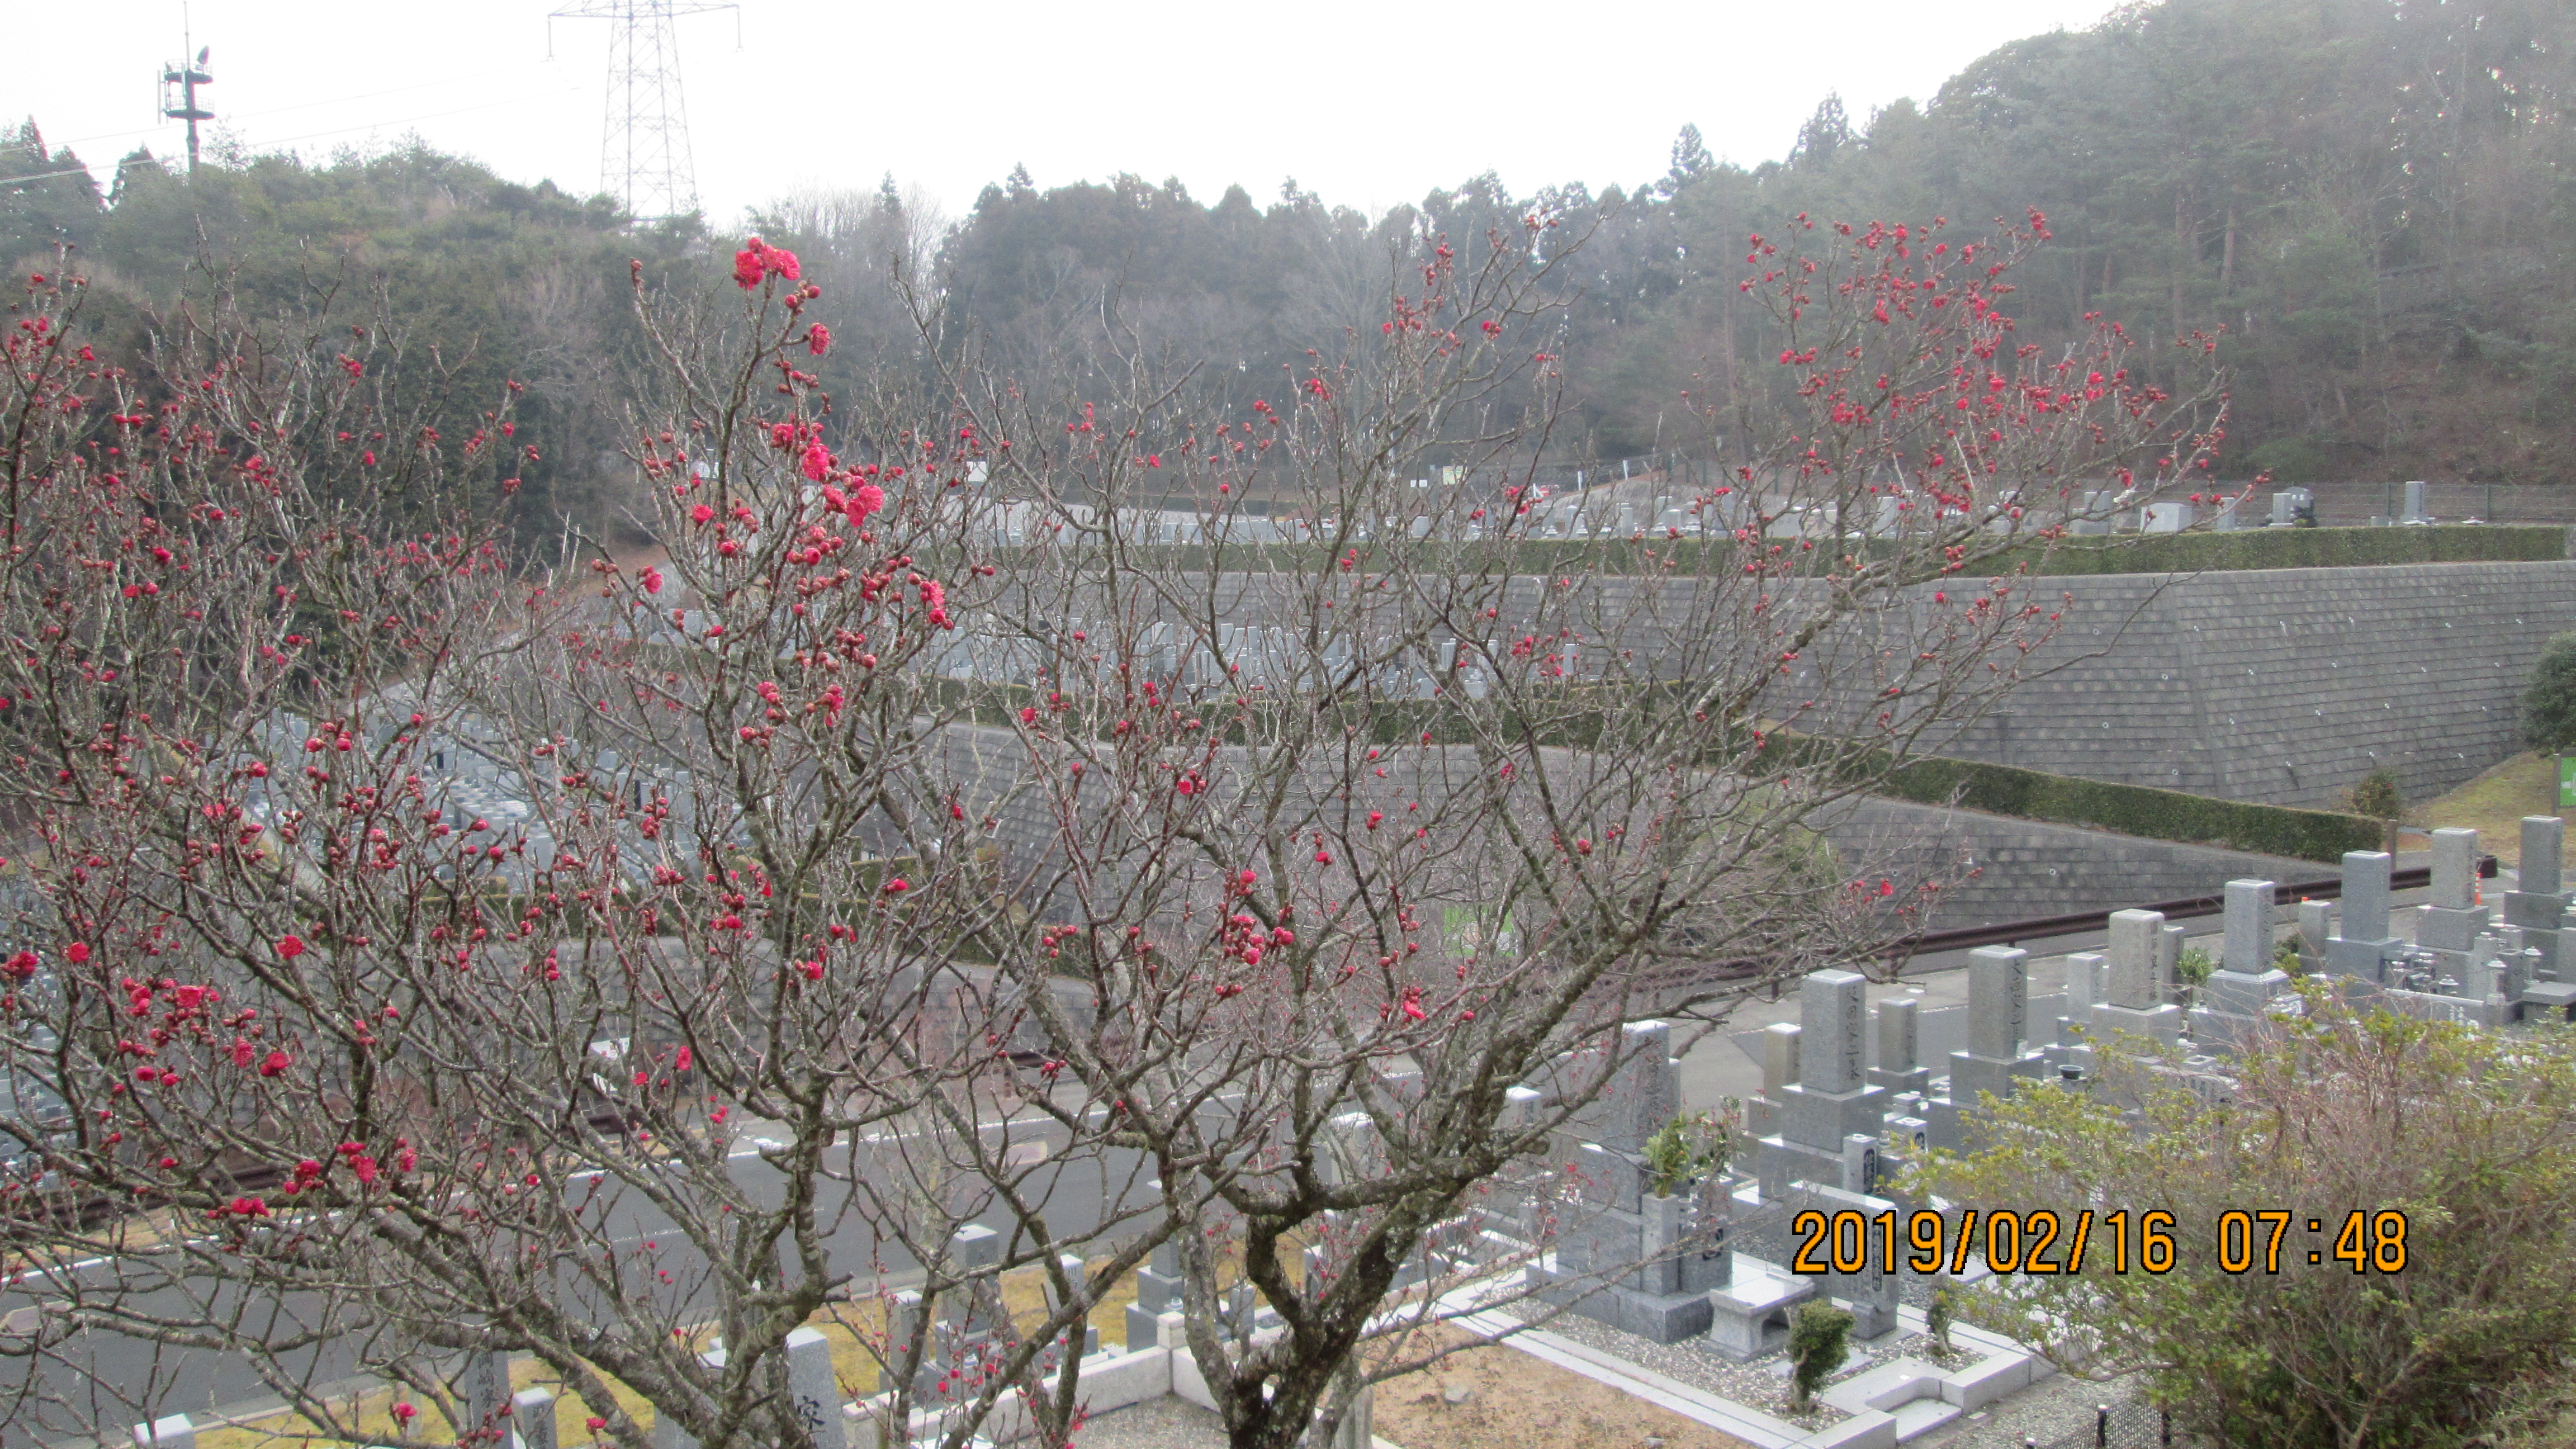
[0,201,2218,1449]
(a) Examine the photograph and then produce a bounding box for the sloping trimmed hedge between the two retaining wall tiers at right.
[1878,758,2380,864]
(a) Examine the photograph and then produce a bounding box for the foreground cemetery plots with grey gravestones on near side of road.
[116,799,2576,1449]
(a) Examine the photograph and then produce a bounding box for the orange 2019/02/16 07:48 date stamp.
[1791,1206,2406,1273]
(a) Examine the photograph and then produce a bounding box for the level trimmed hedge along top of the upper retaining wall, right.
[2030,523,2568,575]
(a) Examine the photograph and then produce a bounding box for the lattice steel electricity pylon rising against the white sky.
[546,0,742,222]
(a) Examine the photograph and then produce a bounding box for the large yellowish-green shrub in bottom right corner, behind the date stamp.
[1906,980,2576,1449]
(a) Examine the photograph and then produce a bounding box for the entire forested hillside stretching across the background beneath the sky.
[0,0,2576,538]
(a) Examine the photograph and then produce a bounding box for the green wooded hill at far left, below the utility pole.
[0,140,690,552]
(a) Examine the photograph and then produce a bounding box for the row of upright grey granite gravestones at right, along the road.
[1533,817,2576,1359]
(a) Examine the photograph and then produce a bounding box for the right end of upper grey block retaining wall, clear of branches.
[1935,560,2576,804]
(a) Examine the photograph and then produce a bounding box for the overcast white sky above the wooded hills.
[0,0,2110,227]
